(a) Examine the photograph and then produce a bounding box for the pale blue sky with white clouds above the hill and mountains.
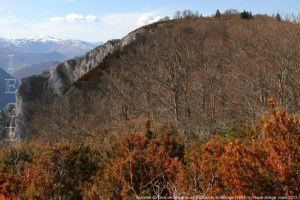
[0,0,300,41]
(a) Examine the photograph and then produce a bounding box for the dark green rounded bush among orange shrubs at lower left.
[50,144,98,199]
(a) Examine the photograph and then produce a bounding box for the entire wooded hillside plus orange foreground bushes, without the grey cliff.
[0,11,300,200]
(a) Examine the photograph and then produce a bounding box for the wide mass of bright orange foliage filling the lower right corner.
[172,103,300,197]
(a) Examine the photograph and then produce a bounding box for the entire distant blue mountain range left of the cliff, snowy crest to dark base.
[0,36,101,109]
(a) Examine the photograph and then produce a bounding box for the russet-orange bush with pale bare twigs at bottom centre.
[104,134,184,199]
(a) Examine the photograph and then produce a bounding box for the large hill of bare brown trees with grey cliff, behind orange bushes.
[17,16,300,137]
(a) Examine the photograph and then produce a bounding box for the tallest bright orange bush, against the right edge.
[219,106,300,196]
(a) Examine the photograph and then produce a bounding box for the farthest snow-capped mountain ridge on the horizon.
[0,36,101,58]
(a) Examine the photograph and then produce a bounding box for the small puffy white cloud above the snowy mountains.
[49,13,100,23]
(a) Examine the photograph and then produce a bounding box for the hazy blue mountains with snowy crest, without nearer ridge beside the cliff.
[0,36,101,73]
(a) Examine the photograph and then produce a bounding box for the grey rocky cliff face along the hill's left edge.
[16,28,144,138]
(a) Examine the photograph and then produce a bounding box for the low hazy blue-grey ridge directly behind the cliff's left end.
[12,61,60,80]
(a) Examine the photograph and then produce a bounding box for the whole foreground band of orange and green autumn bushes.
[0,99,300,199]
